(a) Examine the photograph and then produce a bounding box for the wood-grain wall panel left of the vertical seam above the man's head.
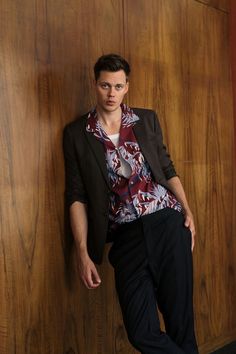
[0,0,132,354]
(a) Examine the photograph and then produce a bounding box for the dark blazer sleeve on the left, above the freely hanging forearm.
[63,126,87,207]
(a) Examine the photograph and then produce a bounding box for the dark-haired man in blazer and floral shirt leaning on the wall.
[64,54,198,354]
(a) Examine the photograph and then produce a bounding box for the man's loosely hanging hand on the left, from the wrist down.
[77,250,101,289]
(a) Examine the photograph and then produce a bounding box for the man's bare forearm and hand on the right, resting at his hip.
[167,176,196,251]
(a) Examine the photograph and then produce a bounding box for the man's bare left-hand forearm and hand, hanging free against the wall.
[70,201,101,289]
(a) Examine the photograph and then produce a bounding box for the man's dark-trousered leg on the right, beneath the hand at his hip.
[143,209,198,354]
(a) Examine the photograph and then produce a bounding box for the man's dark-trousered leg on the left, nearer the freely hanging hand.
[109,219,185,354]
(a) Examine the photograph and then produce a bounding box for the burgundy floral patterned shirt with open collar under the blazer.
[86,104,182,224]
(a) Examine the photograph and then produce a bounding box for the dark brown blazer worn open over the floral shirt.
[63,108,176,264]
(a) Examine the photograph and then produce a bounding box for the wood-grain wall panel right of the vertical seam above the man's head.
[125,0,236,352]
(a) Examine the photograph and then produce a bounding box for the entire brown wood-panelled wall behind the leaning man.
[0,0,236,354]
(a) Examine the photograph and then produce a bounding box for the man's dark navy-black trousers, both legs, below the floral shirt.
[108,208,198,354]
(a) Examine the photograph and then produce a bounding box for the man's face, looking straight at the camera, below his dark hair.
[95,70,129,113]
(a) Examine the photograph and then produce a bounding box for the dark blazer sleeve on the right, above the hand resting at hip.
[154,112,177,180]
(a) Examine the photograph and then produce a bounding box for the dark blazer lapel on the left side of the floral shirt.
[85,132,111,189]
